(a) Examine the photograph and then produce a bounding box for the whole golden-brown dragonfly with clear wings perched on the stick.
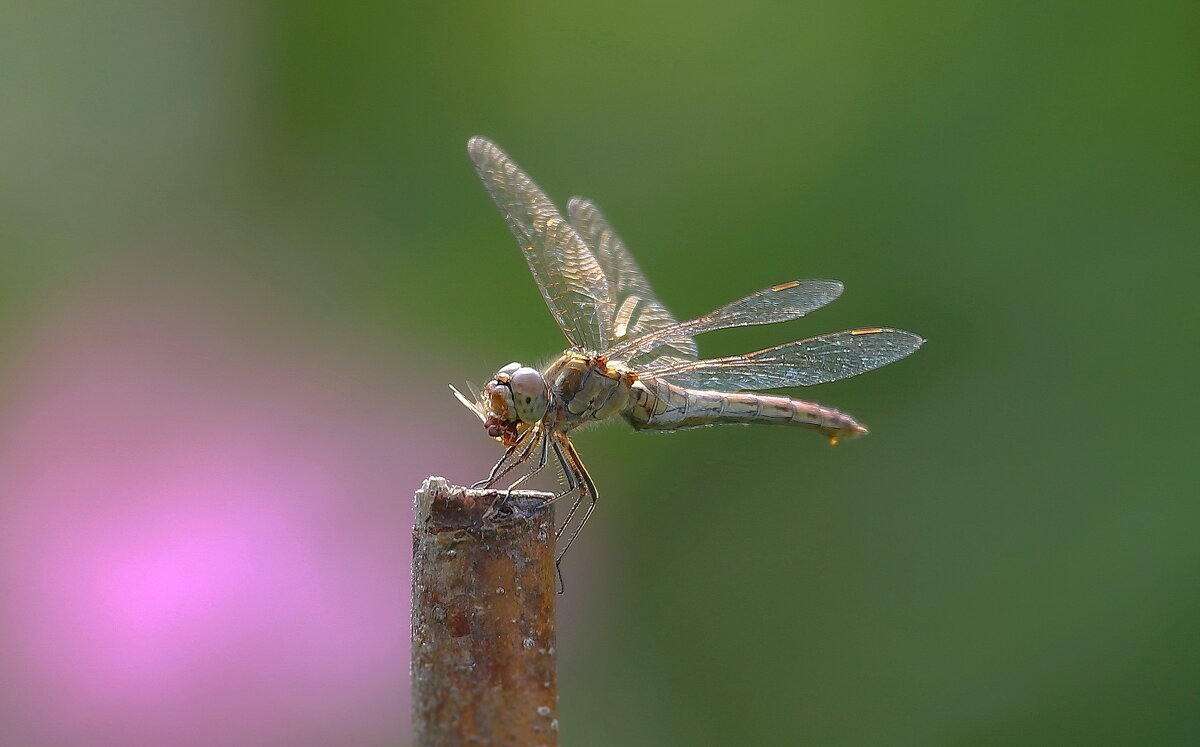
[450,137,924,562]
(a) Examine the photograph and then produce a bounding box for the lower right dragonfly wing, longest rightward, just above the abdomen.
[638,328,924,392]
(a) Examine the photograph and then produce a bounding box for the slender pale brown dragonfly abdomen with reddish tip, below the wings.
[629,380,866,443]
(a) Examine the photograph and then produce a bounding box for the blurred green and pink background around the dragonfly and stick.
[0,0,1200,746]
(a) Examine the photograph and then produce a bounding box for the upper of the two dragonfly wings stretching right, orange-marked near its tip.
[606,280,842,366]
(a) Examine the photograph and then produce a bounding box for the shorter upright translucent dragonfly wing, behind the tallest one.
[566,197,698,365]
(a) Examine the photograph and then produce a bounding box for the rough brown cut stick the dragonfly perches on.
[412,477,558,747]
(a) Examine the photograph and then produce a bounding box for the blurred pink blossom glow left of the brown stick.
[0,279,491,746]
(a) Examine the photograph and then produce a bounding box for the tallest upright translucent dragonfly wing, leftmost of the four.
[467,137,613,351]
